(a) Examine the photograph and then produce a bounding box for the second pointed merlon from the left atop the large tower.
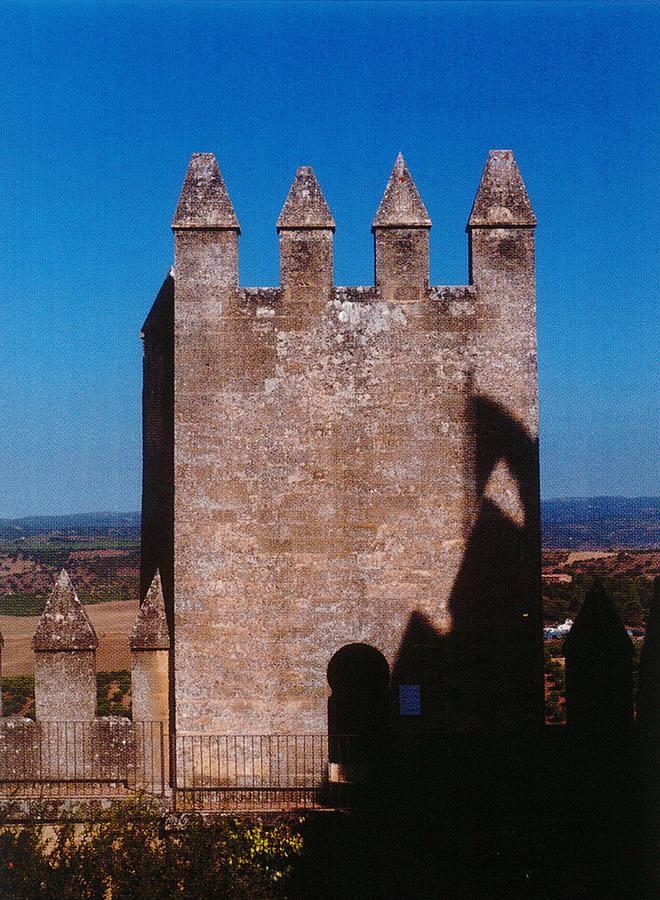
[277,166,335,301]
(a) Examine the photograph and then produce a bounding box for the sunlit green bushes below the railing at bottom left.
[0,804,303,900]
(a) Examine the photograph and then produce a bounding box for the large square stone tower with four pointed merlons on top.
[142,150,543,734]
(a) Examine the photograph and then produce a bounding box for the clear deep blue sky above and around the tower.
[0,2,660,516]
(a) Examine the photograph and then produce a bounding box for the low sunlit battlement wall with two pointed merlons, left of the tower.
[0,570,170,797]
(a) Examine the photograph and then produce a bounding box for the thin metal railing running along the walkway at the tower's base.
[0,717,361,810]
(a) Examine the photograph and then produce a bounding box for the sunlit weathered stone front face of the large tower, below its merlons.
[170,288,533,732]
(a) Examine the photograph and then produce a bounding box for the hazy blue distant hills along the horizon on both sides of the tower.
[0,497,660,550]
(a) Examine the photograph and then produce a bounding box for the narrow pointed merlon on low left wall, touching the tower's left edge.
[130,572,170,722]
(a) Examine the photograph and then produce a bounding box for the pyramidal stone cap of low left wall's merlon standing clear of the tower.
[32,569,98,650]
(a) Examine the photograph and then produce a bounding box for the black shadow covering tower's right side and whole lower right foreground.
[326,396,660,900]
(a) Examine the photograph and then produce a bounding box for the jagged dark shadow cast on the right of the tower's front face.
[392,386,543,734]
